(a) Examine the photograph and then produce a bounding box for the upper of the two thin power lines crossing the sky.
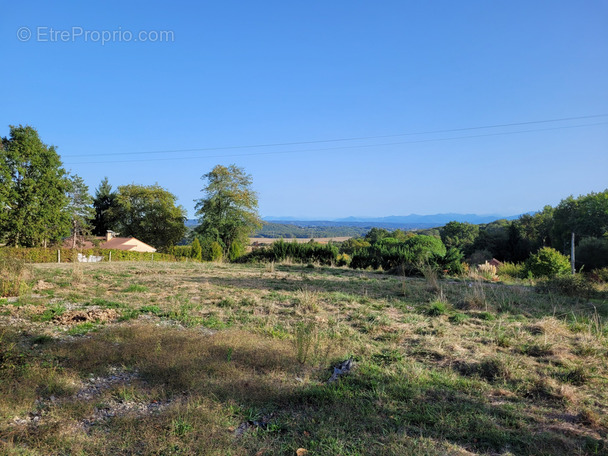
[64,114,608,157]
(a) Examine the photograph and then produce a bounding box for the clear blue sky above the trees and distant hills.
[0,0,608,219]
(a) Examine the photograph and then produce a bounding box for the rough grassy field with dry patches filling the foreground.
[0,263,608,456]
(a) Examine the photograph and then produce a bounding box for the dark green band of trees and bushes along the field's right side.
[240,190,608,277]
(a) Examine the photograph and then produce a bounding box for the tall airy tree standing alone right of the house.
[196,165,262,258]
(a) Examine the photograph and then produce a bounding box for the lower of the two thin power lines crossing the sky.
[66,116,608,165]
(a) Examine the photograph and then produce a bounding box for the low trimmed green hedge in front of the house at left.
[0,247,180,263]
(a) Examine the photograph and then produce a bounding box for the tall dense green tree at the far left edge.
[0,125,70,247]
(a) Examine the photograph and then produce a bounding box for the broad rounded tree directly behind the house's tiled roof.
[110,184,186,249]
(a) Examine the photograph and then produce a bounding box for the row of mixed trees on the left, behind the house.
[0,126,186,250]
